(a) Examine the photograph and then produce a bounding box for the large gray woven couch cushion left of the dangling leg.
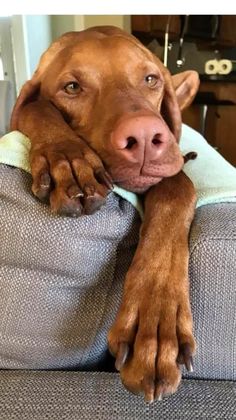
[0,165,140,369]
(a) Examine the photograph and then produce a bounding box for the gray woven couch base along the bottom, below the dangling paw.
[0,371,236,420]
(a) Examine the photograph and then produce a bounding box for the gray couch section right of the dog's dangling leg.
[190,203,236,380]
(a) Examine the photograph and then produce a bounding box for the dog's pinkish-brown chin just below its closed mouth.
[115,175,163,194]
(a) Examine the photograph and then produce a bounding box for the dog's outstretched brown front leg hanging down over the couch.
[108,172,196,402]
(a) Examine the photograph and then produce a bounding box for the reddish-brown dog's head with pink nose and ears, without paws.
[12,27,199,192]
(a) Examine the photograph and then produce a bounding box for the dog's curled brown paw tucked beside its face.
[30,139,112,217]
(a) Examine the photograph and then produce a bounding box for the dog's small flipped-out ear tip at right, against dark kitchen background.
[172,70,200,111]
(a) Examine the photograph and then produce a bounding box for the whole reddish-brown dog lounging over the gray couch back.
[12,27,199,401]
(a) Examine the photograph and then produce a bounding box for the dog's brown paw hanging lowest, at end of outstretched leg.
[108,274,195,402]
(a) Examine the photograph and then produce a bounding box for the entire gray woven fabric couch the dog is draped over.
[0,165,236,420]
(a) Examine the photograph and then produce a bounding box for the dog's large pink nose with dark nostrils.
[111,115,169,163]
